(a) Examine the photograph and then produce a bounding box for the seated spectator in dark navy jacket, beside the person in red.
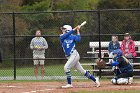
[108,36,120,63]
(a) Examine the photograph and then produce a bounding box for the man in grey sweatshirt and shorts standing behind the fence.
[30,30,48,79]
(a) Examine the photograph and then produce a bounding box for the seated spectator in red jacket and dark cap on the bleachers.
[121,33,137,63]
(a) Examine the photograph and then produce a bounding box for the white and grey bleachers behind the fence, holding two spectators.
[81,41,140,77]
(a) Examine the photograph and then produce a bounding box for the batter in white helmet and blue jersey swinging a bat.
[60,25,100,88]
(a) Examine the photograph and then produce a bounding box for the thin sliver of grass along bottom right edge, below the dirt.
[73,90,140,93]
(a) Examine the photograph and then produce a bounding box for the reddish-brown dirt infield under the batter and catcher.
[0,81,140,93]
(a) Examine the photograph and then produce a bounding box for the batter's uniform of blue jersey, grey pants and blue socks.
[60,30,99,86]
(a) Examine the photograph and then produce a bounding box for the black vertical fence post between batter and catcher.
[97,10,102,78]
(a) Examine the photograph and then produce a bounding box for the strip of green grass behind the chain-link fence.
[0,60,95,77]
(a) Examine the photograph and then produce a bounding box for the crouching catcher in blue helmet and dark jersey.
[111,49,133,84]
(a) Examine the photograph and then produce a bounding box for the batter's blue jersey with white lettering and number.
[60,30,81,57]
